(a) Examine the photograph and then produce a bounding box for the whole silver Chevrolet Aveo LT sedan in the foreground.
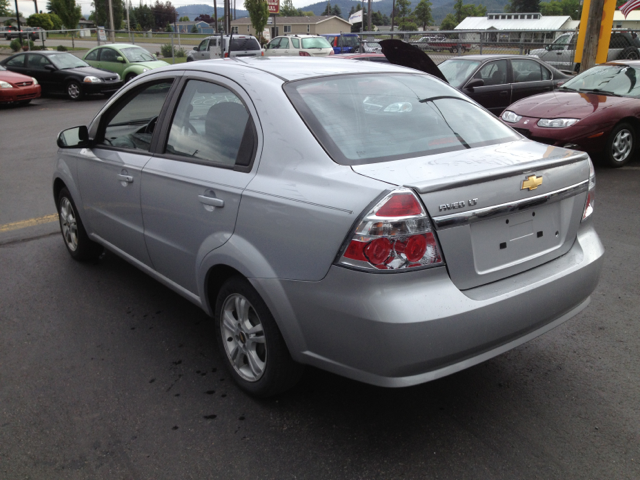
[53,58,604,396]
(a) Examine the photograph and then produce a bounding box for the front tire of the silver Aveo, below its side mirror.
[57,188,104,262]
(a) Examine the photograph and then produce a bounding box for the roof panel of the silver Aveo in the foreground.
[170,57,422,81]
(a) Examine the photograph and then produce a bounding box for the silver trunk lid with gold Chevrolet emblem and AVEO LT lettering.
[352,141,589,290]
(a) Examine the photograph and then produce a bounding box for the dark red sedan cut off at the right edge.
[501,60,640,167]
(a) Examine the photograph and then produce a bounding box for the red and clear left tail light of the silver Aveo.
[337,189,444,271]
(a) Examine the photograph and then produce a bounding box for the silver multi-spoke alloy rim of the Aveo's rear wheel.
[220,293,267,382]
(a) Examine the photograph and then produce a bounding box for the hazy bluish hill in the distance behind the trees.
[176,0,509,25]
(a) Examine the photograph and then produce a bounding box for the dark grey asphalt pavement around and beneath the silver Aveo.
[0,96,640,480]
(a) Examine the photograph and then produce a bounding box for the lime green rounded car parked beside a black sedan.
[83,43,169,82]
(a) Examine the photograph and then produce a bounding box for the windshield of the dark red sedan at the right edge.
[561,65,640,97]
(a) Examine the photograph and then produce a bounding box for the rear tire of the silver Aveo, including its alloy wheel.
[214,276,303,397]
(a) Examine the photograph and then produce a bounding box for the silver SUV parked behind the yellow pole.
[530,32,640,72]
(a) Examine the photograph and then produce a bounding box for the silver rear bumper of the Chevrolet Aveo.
[252,222,604,387]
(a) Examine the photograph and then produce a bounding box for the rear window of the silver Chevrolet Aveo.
[285,74,519,165]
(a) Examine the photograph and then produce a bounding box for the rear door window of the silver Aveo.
[165,80,255,167]
